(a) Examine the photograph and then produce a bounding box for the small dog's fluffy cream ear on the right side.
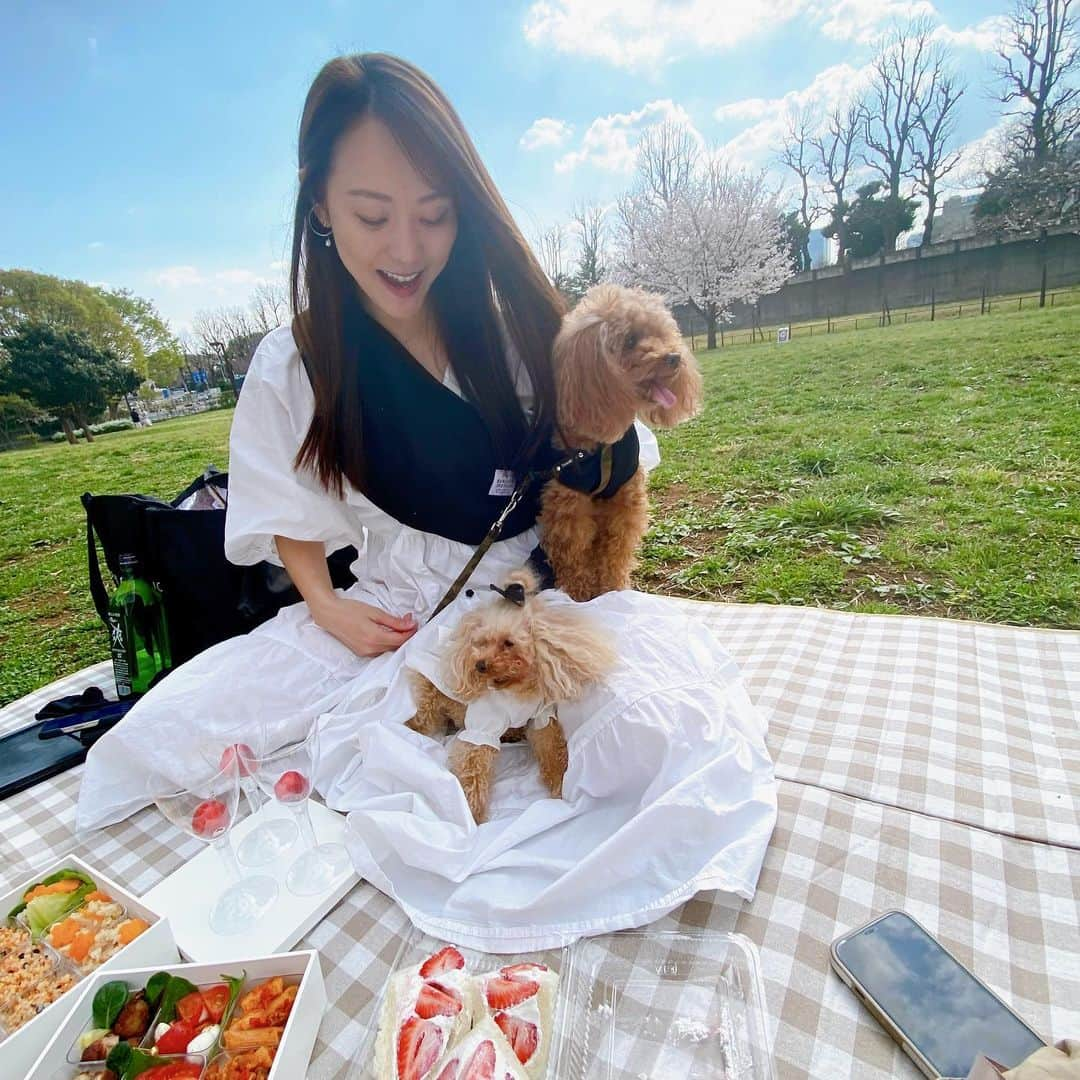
[528,598,616,702]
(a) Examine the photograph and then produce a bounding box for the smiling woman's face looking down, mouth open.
[316,117,458,327]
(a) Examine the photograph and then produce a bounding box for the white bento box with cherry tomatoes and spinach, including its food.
[27,951,326,1080]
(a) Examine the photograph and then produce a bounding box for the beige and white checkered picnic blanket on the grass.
[0,600,1080,1080]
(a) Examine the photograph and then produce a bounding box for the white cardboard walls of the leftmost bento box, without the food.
[0,855,179,1080]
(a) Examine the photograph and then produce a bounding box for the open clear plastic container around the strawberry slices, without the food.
[350,930,773,1080]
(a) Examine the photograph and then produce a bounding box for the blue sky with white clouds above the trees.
[0,0,1007,329]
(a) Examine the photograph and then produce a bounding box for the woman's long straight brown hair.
[289,53,564,495]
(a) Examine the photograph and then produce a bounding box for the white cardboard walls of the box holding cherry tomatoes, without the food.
[26,951,326,1080]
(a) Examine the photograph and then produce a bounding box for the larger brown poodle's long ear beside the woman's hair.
[553,310,636,443]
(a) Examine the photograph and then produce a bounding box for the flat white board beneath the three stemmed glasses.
[145,801,360,962]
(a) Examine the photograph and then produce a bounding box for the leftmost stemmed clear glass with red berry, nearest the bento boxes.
[153,755,279,936]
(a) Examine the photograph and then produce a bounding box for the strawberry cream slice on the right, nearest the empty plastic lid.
[474,963,558,1080]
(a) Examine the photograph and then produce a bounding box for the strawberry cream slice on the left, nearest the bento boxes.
[375,945,475,1080]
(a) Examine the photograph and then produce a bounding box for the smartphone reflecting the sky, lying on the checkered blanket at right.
[832,912,1045,1080]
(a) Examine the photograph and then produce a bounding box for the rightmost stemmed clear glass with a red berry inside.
[254,723,352,896]
